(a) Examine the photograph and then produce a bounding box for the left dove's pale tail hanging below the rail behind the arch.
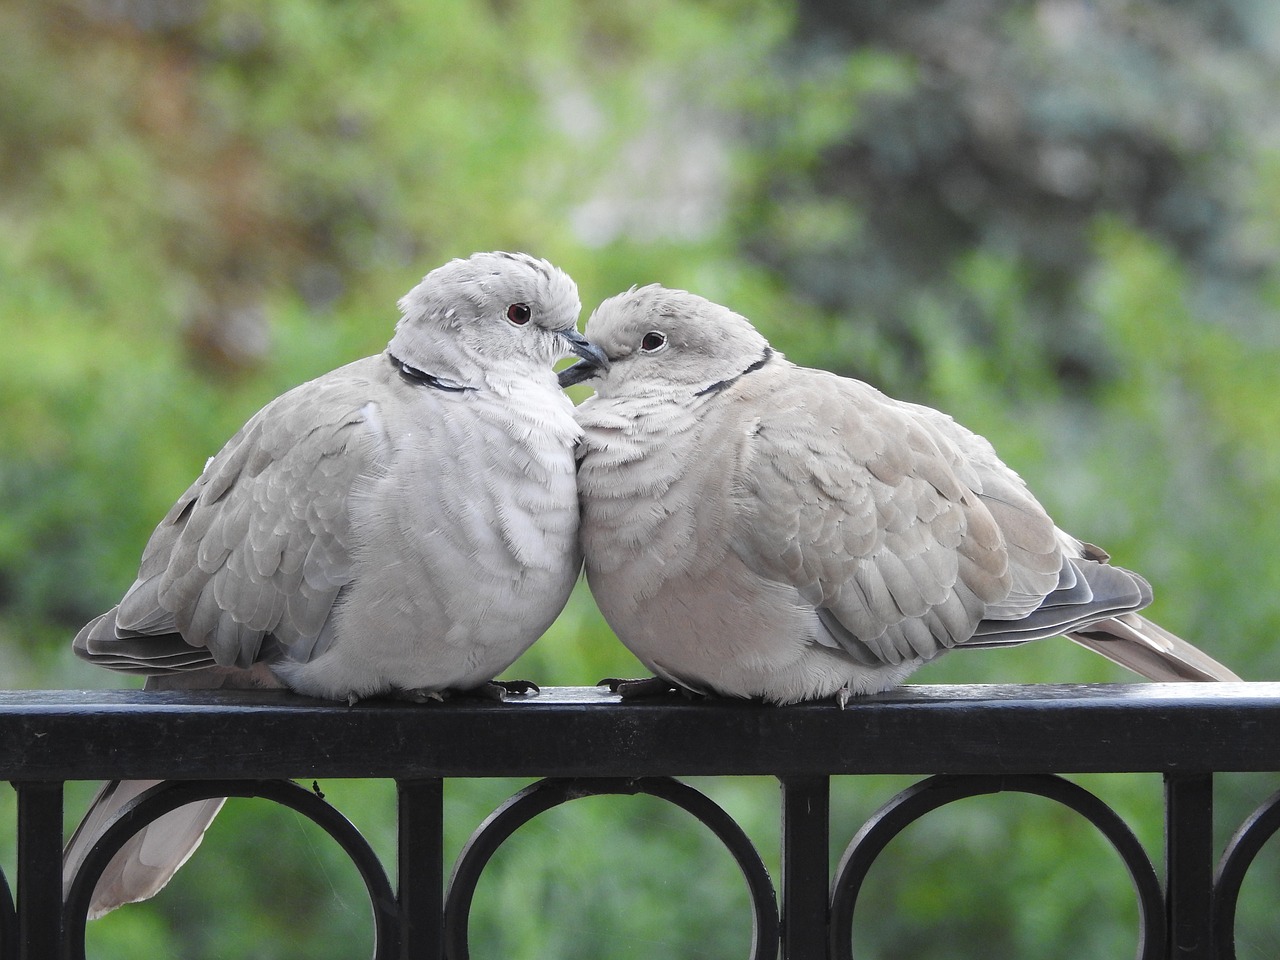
[63,780,225,920]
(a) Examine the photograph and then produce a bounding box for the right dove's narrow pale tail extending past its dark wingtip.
[1066,613,1240,681]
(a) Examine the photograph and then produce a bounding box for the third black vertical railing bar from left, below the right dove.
[780,777,831,960]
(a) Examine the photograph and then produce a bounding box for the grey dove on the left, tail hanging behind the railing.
[64,252,599,916]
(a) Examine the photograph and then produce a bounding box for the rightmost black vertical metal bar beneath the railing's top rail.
[1165,773,1216,960]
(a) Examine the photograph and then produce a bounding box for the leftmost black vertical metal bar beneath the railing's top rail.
[13,781,63,960]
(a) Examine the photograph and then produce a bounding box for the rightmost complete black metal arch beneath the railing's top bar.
[828,774,1166,960]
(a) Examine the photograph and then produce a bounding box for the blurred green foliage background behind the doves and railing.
[0,0,1280,960]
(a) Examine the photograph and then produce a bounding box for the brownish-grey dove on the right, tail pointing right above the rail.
[561,285,1238,705]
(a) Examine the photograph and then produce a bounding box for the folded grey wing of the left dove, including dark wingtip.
[74,367,387,673]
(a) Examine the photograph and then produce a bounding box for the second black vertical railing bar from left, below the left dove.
[396,778,444,960]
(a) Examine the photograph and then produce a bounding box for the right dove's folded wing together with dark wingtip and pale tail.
[713,365,1238,681]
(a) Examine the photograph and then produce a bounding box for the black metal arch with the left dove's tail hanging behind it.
[63,780,399,960]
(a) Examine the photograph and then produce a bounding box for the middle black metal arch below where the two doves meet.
[444,777,778,960]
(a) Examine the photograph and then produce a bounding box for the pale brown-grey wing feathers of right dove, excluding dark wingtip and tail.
[735,367,1061,664]
